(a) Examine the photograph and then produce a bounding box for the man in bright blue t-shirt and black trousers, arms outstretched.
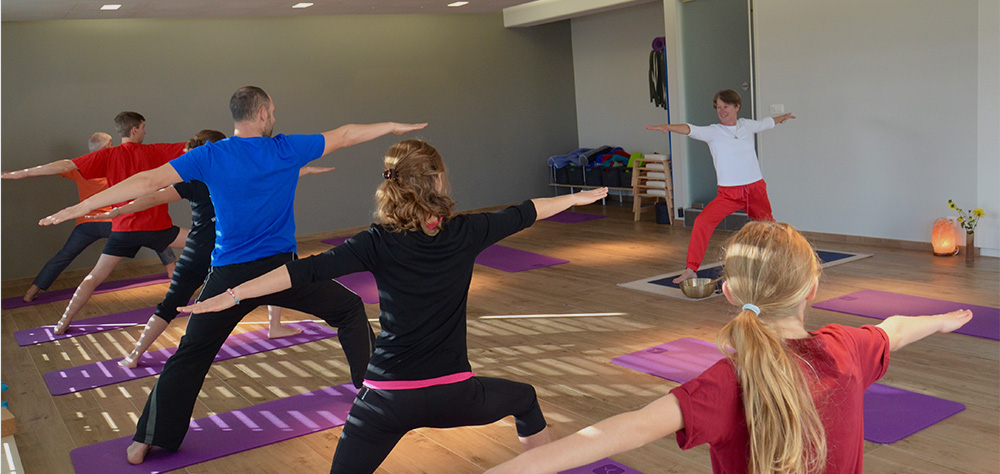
[45,86,427,464]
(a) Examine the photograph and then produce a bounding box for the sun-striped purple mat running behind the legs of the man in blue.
[43,321,337,395]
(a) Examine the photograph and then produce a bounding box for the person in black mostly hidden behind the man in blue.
[104,130,333,369]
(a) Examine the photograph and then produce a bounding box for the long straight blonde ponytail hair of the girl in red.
[716,222,827,474]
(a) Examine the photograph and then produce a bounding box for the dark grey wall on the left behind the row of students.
[0,13,577,279]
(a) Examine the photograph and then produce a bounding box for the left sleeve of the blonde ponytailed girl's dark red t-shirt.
[670,359,746,449]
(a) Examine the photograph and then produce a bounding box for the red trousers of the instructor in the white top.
[687,179,774,271]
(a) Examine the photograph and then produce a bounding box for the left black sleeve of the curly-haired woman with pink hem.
[285,230,375,288]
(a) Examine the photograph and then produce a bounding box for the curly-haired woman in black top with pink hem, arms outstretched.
[179,140,607,474]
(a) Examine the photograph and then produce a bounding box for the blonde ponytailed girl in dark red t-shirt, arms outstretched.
[487,222,972,474]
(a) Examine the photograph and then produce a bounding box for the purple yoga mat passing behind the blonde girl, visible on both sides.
[611,338,965,444]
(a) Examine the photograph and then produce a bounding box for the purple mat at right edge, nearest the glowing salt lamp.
[813,290,1000,340]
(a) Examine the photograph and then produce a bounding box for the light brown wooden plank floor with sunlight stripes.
[0,203,1000,474]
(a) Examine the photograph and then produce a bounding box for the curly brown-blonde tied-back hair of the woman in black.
[374,140,455,235]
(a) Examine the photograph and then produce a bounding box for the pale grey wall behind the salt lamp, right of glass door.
[754,0,1000,250]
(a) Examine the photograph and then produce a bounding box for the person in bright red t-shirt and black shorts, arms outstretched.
[3,112,187,334]
